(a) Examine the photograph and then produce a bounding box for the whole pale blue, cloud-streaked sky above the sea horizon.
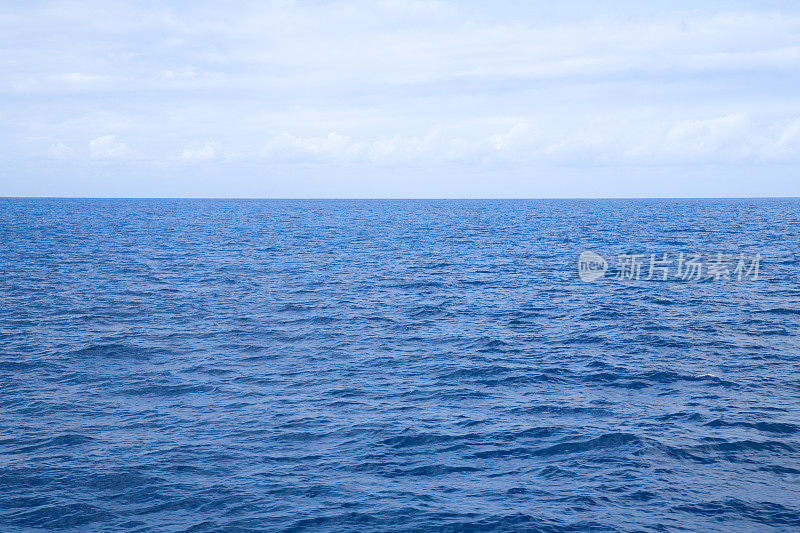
[0,0,800,198]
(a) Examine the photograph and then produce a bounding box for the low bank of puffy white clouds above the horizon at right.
[252,114,800,166]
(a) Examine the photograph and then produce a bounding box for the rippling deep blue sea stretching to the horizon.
[0,200,800,532]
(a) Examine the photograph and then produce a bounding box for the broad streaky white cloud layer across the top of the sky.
[6,0,800,93]
